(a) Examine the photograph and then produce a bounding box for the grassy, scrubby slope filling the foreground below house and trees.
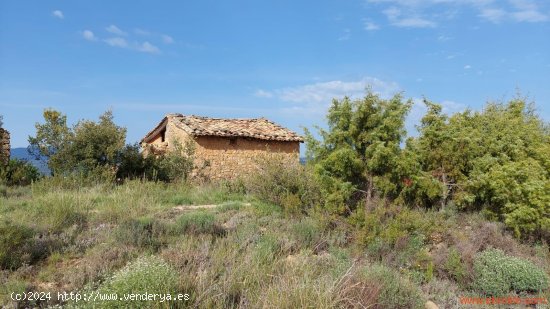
[0,181,550,308]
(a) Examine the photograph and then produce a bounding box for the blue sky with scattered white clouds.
[0,0,550,147]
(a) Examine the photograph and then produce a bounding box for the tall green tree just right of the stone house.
[305,89,412,213]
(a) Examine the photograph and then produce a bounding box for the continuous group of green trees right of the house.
[306,91,550,239]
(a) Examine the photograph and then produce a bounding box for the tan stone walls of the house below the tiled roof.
[144,115,300,180]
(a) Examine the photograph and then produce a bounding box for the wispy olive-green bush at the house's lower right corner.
[245,155,321,214]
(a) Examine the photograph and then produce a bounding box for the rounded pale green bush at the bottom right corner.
[472,249,548,295]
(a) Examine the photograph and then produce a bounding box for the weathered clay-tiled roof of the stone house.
[144,114,304,142]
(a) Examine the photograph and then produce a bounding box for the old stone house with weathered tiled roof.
[141,114,304,180]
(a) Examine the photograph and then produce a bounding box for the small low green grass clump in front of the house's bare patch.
[175,211,223,235]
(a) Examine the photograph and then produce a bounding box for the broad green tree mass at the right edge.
[407,97,550,238]
